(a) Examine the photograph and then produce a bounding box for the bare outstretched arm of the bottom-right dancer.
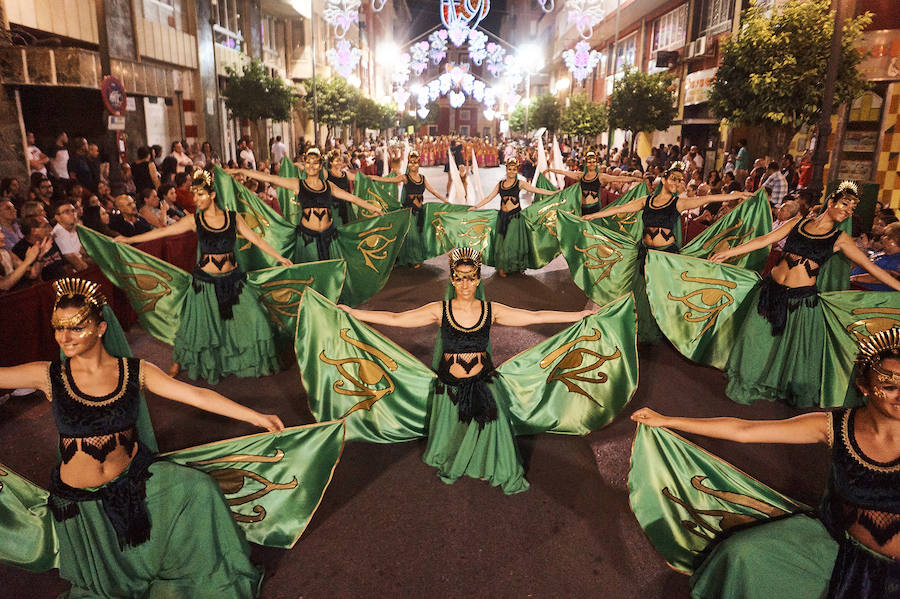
[631,408,830,444]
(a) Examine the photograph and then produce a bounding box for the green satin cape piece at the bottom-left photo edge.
[0,464,59,572]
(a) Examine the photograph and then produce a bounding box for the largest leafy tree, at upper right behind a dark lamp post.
[709,0,872,156]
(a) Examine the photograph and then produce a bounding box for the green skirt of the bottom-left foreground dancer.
[53,460,262,599]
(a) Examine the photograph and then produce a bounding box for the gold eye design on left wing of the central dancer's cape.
[319,329,397,418]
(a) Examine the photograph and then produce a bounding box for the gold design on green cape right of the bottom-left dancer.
[187,449,300,523]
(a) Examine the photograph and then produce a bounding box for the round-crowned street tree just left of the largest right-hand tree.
[607,69,677,155]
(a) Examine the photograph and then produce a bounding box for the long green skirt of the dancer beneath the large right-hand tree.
[724,282,824,408]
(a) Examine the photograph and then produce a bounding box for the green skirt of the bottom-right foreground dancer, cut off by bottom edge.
[691,514,838,599]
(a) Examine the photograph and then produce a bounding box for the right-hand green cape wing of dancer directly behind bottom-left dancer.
[247,260,347,335]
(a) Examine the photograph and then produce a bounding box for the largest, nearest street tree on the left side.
[222,58,297,123]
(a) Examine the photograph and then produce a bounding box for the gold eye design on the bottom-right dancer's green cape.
[662,475,788,541]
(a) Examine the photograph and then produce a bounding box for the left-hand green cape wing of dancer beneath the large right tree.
[644,250,759,370]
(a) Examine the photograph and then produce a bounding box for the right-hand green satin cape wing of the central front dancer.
[494,294,638,435]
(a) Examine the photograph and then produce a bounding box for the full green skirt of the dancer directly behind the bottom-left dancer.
[172,274,280,384]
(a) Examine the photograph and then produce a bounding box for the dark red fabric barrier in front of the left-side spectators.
[0,233,197,366]
